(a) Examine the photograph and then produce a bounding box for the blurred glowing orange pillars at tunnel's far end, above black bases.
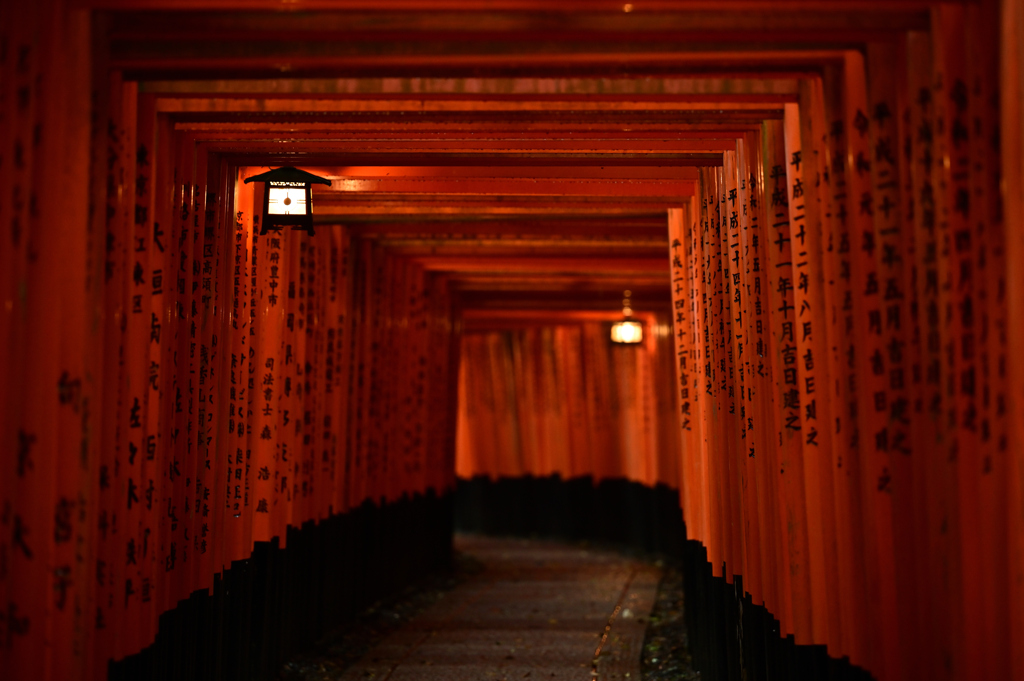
[457,321,674,485]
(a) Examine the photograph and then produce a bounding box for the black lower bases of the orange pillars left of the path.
[110,492,453,681]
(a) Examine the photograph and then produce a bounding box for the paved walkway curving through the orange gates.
[343,537,659,681]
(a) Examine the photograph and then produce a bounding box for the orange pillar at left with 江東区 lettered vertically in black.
[120,91,156,657]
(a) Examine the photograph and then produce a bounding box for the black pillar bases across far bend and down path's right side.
[455,476,872,681]
